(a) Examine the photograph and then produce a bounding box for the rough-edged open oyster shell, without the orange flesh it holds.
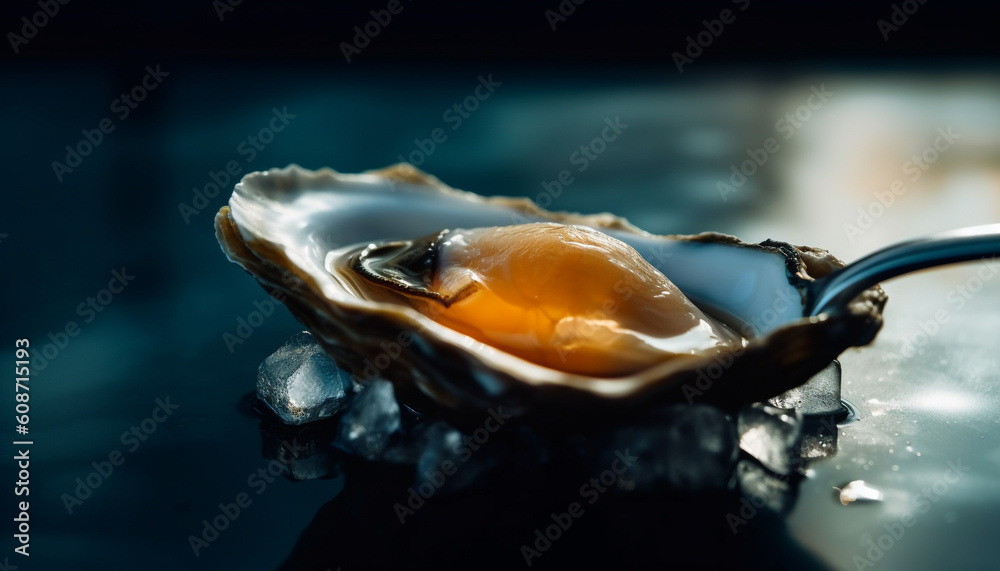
[215,164,885,414]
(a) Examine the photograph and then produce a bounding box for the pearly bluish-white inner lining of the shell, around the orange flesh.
[230,170,803,336]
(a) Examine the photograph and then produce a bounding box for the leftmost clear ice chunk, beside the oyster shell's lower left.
[257,331,353,424]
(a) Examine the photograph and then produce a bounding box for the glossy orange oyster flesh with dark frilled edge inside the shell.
[348,223,744,377]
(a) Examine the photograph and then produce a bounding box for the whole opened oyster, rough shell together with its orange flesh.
[215,164,885,413]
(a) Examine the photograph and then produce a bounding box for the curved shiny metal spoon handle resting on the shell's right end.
[806,224,1000,315]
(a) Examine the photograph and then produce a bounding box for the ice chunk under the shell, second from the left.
[334,379,401,460]
